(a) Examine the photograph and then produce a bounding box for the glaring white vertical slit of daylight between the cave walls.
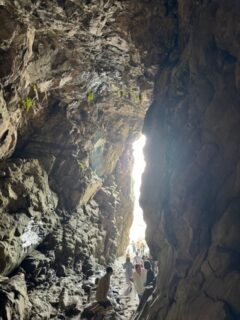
[130,135,146,241]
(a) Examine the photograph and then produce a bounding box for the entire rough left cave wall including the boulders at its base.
[0,0,157,319]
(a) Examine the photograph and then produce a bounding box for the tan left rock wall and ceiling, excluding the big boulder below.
[0,0,152,268]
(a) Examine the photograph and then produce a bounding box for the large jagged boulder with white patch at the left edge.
[0,160,57,275]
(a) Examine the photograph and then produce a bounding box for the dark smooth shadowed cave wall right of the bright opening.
[138,0,240,320]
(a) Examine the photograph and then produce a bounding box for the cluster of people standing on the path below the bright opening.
[123,251,155,300]
